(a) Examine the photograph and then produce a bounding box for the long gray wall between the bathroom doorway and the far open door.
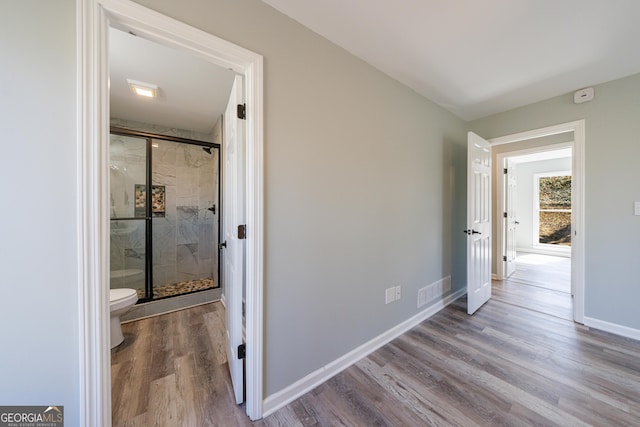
[127,0,466,396]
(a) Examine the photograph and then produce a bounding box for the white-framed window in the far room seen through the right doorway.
[534,172,571,246]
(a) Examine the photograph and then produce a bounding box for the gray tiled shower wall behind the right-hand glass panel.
[152,140,220,286]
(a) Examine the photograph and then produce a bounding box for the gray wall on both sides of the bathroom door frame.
[0,0,466,416]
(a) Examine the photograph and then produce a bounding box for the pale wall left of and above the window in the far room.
[516,157,571,251]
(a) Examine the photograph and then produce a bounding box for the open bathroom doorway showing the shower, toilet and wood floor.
[109,22,245,425]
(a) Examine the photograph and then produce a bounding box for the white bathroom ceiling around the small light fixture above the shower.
[109,28,235,133]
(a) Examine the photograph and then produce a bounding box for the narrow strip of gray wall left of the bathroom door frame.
[0,0,79,426]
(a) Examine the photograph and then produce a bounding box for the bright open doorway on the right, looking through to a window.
[494,145,573,320]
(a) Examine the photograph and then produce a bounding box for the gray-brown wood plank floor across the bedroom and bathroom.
[112,260,640,427]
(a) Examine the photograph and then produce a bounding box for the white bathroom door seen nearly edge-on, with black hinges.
[223,76,245,404]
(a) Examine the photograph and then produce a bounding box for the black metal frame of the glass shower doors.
[109,126,223,304]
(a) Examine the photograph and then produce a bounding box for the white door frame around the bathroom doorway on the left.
[76,0,264,426]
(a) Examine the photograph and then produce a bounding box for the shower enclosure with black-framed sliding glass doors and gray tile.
[110,129,220,302]
